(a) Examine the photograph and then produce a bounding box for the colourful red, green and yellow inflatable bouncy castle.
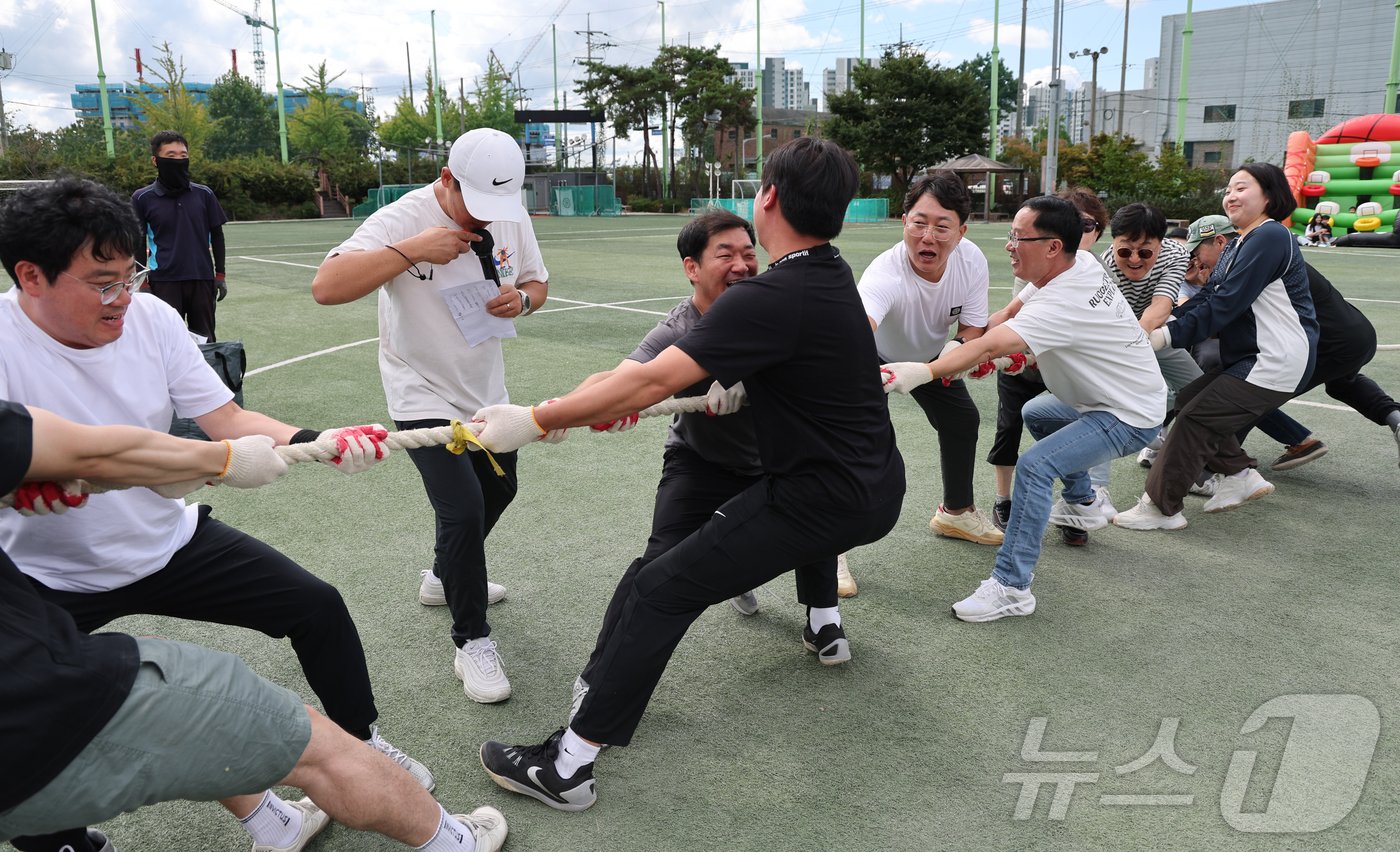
[1284,115,1400,248]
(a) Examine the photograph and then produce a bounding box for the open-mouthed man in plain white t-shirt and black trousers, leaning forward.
[858,171,1002,544]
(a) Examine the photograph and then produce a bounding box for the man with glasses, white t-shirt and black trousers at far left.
[0,178,433,851]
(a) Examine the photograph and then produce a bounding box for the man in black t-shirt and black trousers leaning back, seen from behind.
[473,137,904,810]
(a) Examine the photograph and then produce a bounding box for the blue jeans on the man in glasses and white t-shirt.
[991,395,1162,589]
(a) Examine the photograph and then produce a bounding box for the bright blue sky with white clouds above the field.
[0,0,1243,130]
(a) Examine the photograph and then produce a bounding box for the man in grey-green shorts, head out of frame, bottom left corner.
[0,400,507,852]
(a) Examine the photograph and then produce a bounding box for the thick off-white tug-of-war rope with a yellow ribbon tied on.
[0,354,1035,509]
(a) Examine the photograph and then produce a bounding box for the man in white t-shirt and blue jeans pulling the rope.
[885,196,1166,621]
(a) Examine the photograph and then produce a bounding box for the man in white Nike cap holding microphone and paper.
[311,127,549,704]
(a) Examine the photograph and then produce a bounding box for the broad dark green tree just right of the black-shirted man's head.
[823,46,987,193]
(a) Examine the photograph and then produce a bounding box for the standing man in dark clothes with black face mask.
[132,130,228,343]
